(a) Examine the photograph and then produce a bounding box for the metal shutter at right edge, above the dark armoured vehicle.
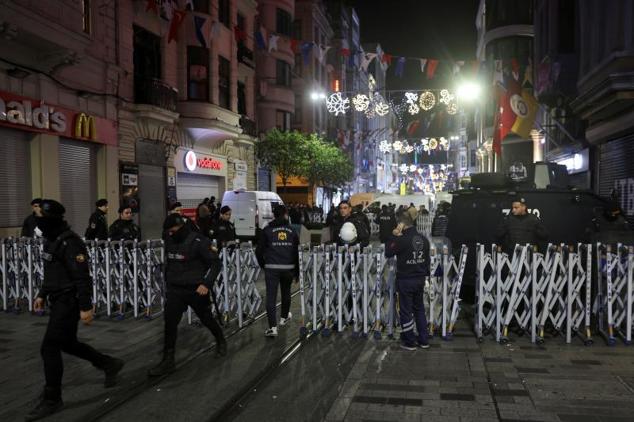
[599,134,634,224]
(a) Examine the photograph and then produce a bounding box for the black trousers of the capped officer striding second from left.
[165,285,225,350]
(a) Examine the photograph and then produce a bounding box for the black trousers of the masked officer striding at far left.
[41,290,108,394]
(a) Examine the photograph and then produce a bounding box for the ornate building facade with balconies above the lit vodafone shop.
[117,0,257,238]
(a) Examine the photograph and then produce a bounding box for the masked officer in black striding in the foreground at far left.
[26,199,123,421]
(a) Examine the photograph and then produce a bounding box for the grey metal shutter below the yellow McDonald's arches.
[59,139,97,236]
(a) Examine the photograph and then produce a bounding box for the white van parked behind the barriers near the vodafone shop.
[222,190,284,239]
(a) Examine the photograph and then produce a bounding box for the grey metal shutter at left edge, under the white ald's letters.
[0,129,33,227]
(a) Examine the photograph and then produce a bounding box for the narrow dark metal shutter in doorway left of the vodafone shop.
[139,164,165,239]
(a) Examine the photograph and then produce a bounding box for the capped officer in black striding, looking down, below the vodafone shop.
[148,214,227,376]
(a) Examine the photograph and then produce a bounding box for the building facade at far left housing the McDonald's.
[0,0,120,237]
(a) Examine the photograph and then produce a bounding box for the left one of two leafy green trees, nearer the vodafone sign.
[256,129,307,189]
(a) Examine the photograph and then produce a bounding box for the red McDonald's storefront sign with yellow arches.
[0,91,117,145]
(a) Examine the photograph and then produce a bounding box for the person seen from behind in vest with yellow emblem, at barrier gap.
[255,205,299,337]
